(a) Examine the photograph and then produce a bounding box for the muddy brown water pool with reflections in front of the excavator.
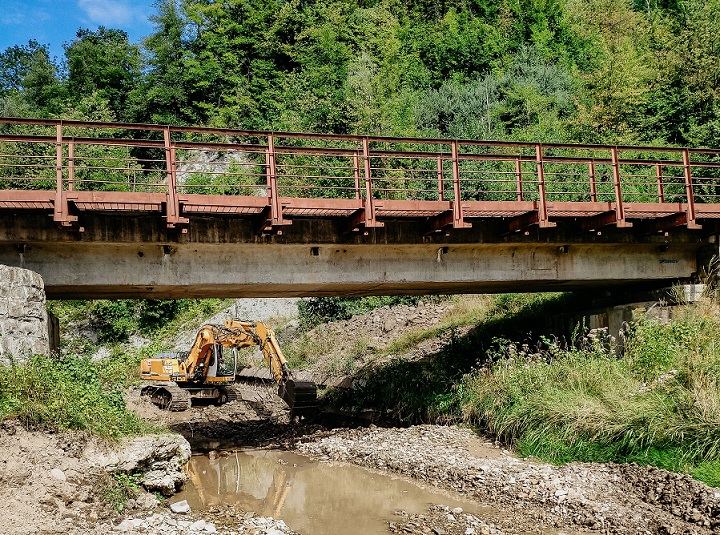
[176,450,488,535]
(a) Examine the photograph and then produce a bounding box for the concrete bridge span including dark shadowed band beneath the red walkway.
[0,214,712,299]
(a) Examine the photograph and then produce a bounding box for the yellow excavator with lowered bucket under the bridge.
[140,320,317,419]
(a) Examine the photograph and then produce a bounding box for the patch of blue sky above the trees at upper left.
[0,0,155,59]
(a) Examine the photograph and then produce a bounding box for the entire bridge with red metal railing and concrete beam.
[0,118,720,298]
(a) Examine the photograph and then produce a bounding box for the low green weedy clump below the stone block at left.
[0,356,153,438]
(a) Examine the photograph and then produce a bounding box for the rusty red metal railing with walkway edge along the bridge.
[0,118,720,232]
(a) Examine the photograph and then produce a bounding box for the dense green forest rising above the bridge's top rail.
[0,0,720,147]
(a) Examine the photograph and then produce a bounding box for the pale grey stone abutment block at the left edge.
[0,265,50,362]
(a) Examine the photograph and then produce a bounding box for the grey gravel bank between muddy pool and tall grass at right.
[296,425,720,534]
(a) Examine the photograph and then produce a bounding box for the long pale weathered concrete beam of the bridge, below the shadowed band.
[0,241,697,299]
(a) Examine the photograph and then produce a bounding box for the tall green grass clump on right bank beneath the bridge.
[461,307,720,486]
